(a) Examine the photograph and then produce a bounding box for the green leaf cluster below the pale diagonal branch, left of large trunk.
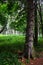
[10,17,26,32]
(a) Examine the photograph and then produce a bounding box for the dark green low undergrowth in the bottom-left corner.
[0,51,21,65]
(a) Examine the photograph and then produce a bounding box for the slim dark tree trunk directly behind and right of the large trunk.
[34,0,38,45]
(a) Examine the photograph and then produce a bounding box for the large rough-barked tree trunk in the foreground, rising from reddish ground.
[24,0,34,59]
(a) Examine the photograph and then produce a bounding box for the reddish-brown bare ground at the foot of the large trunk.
[18,52,43,65]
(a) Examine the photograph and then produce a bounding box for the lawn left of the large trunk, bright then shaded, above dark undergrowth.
[0,35,25,51]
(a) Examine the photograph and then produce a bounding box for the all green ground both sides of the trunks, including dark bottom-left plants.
[0,35,43,65]
